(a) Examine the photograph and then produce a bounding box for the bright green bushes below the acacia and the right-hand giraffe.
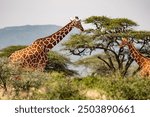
[76,76,150,100]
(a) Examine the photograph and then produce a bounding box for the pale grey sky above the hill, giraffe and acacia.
[0,0,150,30]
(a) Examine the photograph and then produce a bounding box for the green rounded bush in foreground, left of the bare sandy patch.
[30,72,83,100]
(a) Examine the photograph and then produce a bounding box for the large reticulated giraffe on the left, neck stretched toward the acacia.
[9,16,84,71]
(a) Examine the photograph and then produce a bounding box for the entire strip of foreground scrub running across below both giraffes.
[0,57,150,100]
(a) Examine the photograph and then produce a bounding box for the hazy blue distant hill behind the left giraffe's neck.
[0,25,77,49]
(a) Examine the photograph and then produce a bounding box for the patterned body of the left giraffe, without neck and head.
[9,45,48,70]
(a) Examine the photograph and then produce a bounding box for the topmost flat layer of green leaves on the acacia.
[84,16,137,31]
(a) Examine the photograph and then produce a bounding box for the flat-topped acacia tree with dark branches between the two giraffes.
[64,16,150,76]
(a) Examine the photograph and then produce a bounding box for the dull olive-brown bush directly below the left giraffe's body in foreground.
[11,71,48,99]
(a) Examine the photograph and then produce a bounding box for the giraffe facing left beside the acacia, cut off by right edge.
[120,38,150,77]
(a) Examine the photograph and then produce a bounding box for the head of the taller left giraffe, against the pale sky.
[70,16,84,31]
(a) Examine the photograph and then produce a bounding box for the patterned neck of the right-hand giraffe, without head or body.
[128,42,145,67]
